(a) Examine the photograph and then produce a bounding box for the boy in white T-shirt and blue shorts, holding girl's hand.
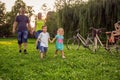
[36,26,51,59]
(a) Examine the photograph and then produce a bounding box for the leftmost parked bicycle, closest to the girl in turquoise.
[66,29,94,50]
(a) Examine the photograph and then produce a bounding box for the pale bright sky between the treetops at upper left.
[0,0,55,14]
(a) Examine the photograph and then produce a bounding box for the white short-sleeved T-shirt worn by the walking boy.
[38,32,50,47]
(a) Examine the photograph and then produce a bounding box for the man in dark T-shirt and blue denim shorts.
[12,8,31,54]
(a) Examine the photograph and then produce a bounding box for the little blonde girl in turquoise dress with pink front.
[52,28,65,58]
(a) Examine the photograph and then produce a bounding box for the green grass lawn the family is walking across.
[0,39,120,80]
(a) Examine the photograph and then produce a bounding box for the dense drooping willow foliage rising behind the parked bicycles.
[56,0,120,38]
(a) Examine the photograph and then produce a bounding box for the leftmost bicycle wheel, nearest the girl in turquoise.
[66,38,80,50]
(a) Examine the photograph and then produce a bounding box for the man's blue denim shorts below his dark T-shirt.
[18,31,28,44]
